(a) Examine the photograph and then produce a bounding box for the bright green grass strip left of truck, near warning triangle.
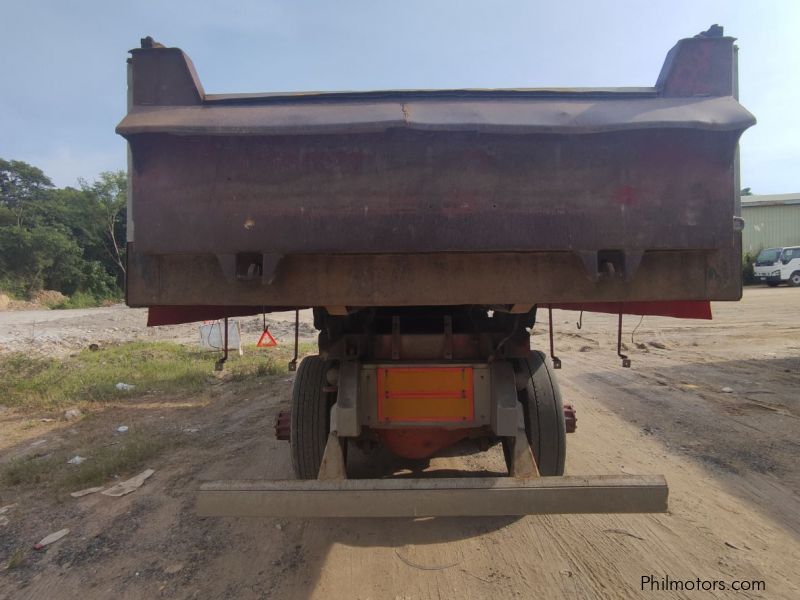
[0,342,288,409]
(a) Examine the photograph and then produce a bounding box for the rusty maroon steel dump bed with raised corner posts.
[117,30,755,310]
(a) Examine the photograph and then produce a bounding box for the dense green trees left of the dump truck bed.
[0,159,127,300]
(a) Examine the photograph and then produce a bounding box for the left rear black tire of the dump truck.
[290,356,333,479]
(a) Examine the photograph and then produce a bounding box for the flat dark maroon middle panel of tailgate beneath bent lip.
[123,129,738,255]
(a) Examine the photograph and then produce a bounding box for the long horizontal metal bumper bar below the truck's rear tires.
[197,475,668,518]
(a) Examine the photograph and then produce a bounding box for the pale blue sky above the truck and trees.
[0,0,800,193]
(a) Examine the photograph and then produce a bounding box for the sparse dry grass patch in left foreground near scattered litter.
[0,432,180,492]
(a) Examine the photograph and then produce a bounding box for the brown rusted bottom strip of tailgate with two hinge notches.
[127,246,741,312]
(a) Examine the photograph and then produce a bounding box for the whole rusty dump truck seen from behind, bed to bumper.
[117,26,755,516]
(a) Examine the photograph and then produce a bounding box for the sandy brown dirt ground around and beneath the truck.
[0,288,800,599]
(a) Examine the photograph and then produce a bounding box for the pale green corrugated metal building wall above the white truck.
[742,204,800,256]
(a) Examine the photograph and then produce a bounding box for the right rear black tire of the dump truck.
[517,351,567,477]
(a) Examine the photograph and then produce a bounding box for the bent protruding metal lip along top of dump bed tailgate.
[117,96,752,138]
